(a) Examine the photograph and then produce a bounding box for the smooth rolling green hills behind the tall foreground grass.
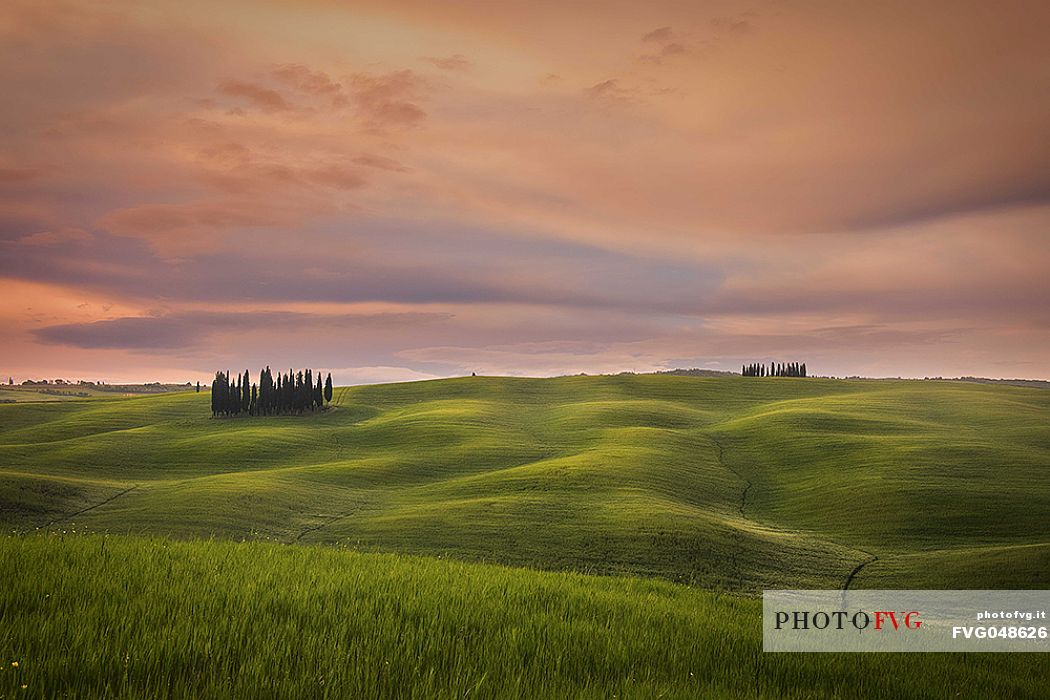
[0,376,1050,592]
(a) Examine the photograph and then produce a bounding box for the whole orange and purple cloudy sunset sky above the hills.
[0,0,1050,383]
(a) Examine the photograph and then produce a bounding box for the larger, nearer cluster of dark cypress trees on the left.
[211,367,332,416]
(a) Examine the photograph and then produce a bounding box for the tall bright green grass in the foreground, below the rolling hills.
[0,534,1050,699]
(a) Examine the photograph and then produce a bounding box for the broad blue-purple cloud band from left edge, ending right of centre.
[0,225,718,312]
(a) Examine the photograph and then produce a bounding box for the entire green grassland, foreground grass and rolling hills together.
[0,376,1050,698]
